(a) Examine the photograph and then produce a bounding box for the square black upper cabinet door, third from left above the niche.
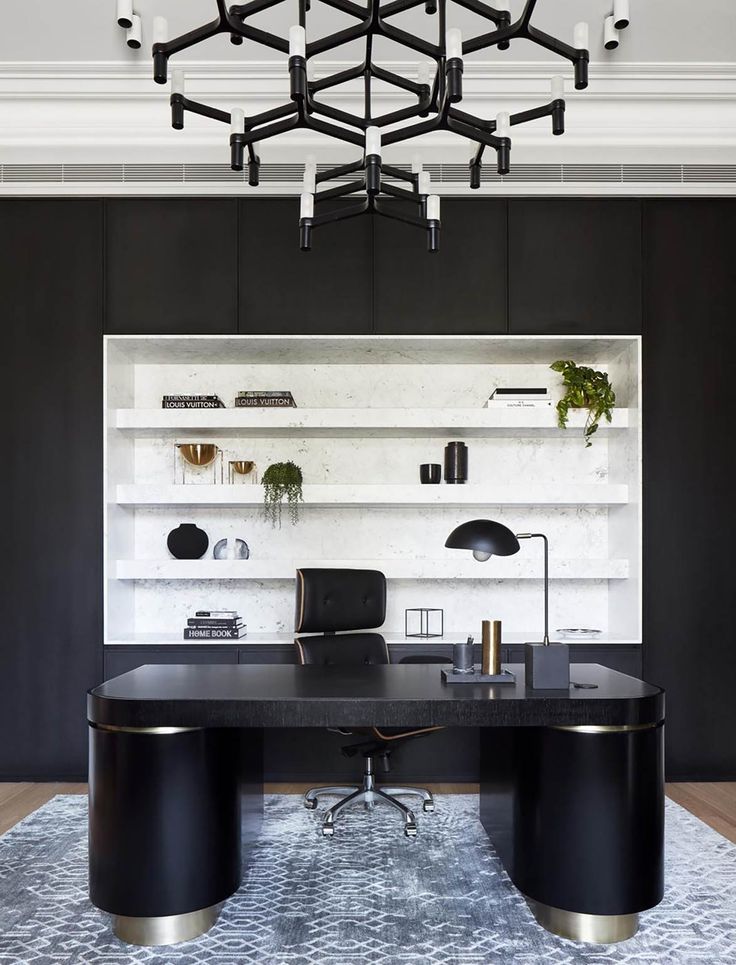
[373,198,507,335]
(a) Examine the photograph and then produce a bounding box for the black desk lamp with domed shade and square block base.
[445,519,570,690]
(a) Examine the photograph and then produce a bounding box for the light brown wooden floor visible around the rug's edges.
[0,781,736,844]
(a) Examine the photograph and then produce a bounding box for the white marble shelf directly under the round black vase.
[114,557,629,580]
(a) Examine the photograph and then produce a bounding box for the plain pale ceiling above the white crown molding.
[0,0,736,65]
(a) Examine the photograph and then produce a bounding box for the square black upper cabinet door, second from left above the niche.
[239,198,373,335]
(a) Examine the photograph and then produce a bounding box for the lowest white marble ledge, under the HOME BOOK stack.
[106,629,641,648]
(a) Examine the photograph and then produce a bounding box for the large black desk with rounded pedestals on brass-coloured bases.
[87,664,664,944]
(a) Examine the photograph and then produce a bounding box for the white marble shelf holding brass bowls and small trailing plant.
[115,483,629,508]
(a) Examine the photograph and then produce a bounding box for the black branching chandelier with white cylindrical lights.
[147,0,589,252]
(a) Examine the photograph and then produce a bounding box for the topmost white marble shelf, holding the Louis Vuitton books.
[113,407,636,437]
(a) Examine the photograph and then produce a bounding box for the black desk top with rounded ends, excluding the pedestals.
[87,664,664,727]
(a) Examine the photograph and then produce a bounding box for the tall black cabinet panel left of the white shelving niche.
[0,200,103,780]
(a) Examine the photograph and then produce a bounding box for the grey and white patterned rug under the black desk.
[0,795,736,965]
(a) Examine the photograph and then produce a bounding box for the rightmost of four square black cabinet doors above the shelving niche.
[509,198,642,335]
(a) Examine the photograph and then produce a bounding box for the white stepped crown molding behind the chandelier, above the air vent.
[0,60,736,164]
